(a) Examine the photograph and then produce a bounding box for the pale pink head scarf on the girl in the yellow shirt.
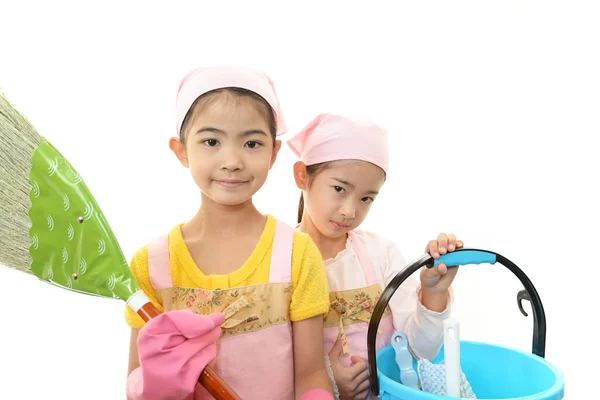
[175,66,287,136]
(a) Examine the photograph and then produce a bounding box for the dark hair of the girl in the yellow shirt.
[179,87,277,146]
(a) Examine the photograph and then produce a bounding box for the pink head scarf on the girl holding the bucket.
[287,114,389,173]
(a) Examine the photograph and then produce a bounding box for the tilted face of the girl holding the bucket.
[295,160,385,239]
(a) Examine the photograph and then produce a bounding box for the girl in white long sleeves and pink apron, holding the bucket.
[288,114,463,399]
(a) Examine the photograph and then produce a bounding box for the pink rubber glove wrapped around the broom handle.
[127,310,225,400]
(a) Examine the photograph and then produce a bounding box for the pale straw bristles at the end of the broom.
[0,92,41,274]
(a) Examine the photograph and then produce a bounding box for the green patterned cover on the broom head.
[29,138,139,301]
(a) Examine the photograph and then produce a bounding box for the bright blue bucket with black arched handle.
[367,249,565,400]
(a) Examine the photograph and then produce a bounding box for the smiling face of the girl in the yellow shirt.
[171,92,281,206]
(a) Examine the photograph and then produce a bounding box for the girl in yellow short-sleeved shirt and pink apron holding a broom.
[126,67,333,400]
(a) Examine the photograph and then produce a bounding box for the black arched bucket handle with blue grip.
[367,249,546,396]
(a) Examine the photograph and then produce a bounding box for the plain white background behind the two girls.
[0,0,600,400]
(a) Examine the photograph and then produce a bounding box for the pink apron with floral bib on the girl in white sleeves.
[324,232,394,399]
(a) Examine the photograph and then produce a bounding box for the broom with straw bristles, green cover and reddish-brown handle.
[0,92,240,400]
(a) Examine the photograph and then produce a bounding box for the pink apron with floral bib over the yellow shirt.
[148,221,294,400]
